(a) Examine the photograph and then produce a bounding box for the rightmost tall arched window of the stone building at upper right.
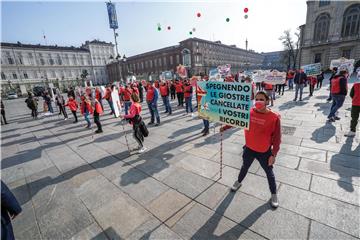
[341,4,360,37]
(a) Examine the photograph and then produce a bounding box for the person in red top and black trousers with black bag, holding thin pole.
[124,93,146,153]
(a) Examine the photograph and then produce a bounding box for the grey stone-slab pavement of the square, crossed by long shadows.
[1,82,360,240]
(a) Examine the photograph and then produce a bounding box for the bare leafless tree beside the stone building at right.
[279,28,300,69]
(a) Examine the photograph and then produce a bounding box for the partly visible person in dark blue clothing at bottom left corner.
[1,180,22,240]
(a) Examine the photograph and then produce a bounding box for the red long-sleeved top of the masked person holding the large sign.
[244,108,281,156]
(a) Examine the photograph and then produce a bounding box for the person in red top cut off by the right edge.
[345,80,360,137]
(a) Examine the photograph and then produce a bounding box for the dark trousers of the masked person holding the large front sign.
[238,146,276,194]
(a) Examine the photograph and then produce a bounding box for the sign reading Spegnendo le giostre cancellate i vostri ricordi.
[197,81,252,129]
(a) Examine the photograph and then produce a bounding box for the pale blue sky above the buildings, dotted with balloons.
[1,0,306,56]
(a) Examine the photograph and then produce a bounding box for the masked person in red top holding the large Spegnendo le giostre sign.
[220,91,281,208]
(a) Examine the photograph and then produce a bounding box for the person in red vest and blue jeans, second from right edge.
[328,69,347,122]
